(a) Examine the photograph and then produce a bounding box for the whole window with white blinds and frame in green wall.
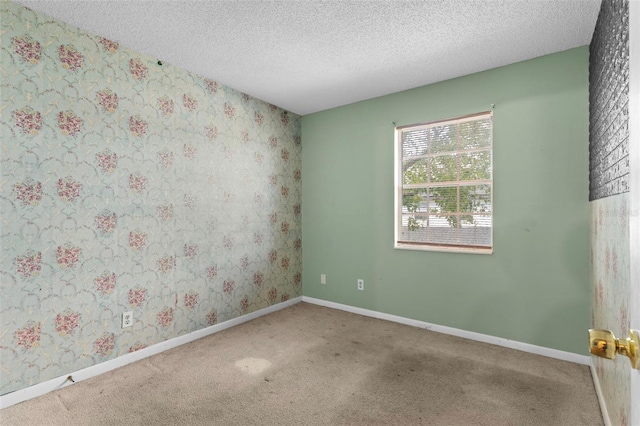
[395,112,493,253]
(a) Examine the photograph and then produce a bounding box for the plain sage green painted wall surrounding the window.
[302,46,590,354]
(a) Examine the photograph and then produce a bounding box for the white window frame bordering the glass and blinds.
[393,111,495,254]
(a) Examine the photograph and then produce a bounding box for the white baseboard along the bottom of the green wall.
[302,296,591,365]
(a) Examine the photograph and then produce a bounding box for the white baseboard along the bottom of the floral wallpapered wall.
[0,296,302,409]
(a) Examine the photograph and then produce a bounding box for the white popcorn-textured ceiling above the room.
[16,0,601,115]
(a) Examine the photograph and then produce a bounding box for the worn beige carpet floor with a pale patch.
[0,303,603,426]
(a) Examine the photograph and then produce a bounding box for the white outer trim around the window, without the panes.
[393,111,495,254]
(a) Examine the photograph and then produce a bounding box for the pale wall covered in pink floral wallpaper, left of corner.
[0,1,302,394]
